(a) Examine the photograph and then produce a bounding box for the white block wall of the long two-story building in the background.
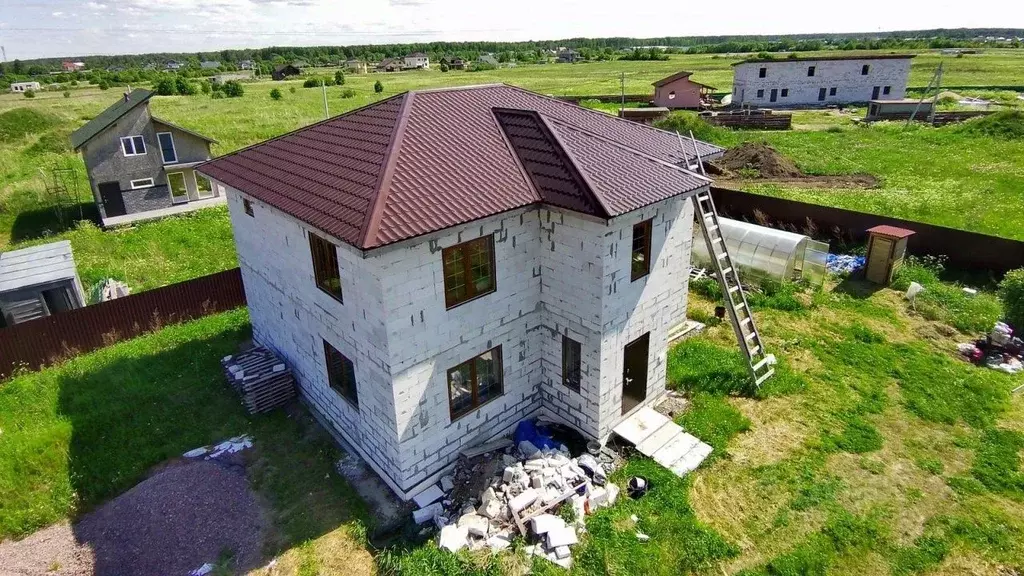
[732,57,910,108]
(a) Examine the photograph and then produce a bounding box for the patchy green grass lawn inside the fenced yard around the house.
[0,264,1024,576]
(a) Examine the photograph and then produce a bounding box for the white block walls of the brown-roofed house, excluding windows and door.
[225,187,707,498]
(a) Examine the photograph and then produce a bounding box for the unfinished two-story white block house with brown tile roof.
[199,85,722,498]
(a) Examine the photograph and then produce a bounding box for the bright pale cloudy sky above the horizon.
[0,0,1024,60]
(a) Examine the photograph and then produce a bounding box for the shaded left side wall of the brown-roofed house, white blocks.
[225,187,401,491]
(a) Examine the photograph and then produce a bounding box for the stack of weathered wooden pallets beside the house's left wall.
[220,346,295,414]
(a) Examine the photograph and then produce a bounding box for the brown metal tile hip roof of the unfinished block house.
[199,85,722,248]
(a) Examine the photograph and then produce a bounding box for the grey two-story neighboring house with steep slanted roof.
[71,89,224,227]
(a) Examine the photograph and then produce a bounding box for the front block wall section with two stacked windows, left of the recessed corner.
[380,209,541,489]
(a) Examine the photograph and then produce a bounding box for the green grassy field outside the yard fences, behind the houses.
[0,50,1024,289]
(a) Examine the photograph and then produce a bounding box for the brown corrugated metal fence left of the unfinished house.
[0,269,246,378]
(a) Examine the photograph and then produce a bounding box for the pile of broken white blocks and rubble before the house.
[413,424,621,568]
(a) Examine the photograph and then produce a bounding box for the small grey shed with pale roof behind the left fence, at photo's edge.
[0,240,85,327]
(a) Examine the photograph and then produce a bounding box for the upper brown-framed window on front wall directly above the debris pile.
[441,236,497,310]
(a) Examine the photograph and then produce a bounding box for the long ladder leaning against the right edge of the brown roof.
[679,133,775,387]
